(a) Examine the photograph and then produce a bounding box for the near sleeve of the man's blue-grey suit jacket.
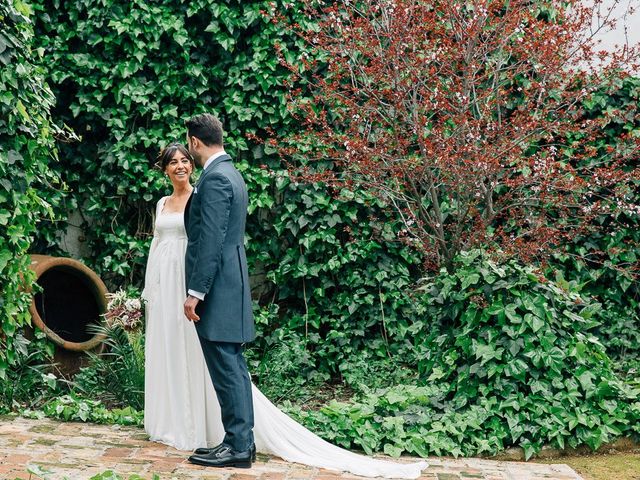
[187,174,233,295]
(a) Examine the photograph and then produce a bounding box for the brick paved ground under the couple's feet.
[0,416,581,480]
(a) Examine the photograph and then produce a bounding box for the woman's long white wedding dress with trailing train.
[142,197,427,478]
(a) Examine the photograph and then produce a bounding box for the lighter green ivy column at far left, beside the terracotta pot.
[0,0,62,379]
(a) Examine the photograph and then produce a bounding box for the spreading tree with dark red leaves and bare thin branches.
[281,0,640,268]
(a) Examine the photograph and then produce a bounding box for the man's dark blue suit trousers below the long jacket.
[198,336,253,452]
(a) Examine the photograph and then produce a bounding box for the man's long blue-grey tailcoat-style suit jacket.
[184,155,255,343]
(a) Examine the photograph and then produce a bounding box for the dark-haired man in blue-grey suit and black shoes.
[184,114,255,468]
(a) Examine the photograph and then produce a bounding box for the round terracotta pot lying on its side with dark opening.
[29,255,107,352]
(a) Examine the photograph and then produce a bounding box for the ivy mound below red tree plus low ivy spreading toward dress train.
[288,252,640,458]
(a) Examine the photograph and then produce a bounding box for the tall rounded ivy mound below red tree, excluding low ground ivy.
[412,252,640,455]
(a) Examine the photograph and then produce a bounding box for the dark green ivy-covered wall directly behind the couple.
[34,0,419,372]
